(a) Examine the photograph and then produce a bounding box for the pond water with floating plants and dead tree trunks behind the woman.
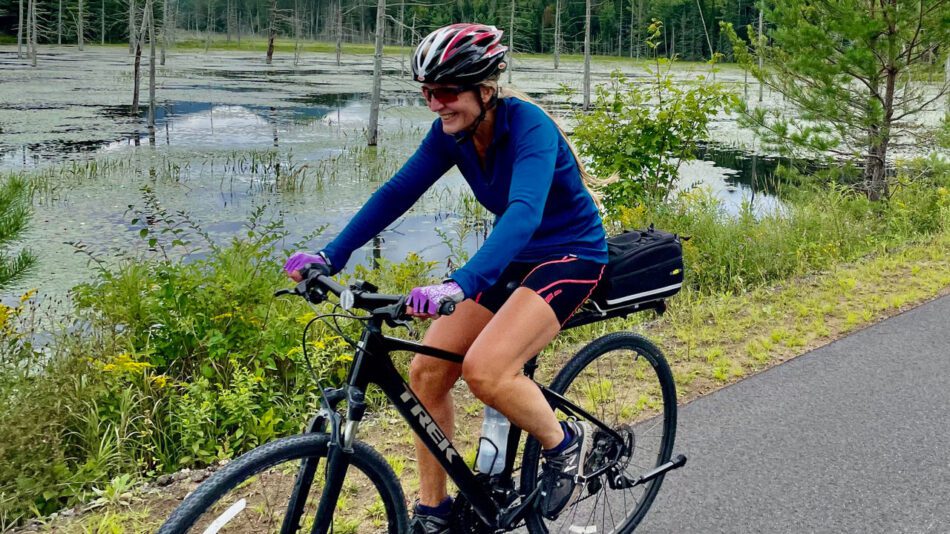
[0,46,779,302]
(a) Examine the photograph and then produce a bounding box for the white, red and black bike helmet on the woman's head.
[412,23,508,85]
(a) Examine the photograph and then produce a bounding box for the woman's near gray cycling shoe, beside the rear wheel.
[539,421,591,519]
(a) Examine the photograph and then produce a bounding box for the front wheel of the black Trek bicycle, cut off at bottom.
[159,433,408,534]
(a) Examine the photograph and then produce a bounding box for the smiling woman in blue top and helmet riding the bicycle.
[285,24,607,534]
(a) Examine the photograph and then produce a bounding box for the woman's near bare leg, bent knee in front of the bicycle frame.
[462,287,564,449]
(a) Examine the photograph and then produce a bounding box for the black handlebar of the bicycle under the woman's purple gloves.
[274,267,455,321]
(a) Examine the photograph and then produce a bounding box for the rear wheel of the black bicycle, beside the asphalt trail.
[521,332,676,534]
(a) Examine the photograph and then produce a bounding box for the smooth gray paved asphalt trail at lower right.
[637,296,950,534]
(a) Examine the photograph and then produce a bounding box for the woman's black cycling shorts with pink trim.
[474,256,605,326]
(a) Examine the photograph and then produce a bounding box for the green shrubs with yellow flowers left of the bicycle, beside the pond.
[0,199,434,526]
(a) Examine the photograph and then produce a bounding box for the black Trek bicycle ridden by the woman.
[159,271,686,534]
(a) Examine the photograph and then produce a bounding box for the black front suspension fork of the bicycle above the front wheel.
[280,385,366,534]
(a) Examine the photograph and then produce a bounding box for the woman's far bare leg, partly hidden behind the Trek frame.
[409,300,492,506]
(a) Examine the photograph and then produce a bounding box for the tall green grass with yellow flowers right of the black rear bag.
[615,166,950,293]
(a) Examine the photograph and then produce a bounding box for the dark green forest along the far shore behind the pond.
[0,0,759,60]
